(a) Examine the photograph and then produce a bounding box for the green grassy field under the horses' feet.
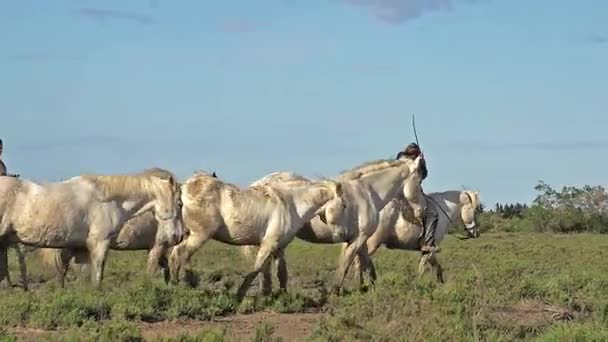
[0,234,608,341]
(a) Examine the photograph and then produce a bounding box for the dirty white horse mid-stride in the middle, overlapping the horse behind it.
[169,172,342,301]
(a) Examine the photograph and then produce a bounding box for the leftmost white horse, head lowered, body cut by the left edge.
[0,168,183,287]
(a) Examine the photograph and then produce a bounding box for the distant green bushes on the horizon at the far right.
[480,181,608,233]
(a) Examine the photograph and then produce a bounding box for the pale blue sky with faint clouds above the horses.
[0,0,608,205]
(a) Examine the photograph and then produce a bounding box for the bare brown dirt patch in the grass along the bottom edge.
[140,312,323,341]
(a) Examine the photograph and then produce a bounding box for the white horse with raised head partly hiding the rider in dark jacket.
[244,158,424,292]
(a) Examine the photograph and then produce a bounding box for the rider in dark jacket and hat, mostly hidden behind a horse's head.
[397,143,439,253]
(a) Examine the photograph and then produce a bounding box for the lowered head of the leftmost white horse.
[146,169,184,244]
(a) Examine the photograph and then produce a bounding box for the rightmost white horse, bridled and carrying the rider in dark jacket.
[355,190,481,283]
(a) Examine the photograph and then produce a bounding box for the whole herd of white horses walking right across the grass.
[0,152,480,300]
